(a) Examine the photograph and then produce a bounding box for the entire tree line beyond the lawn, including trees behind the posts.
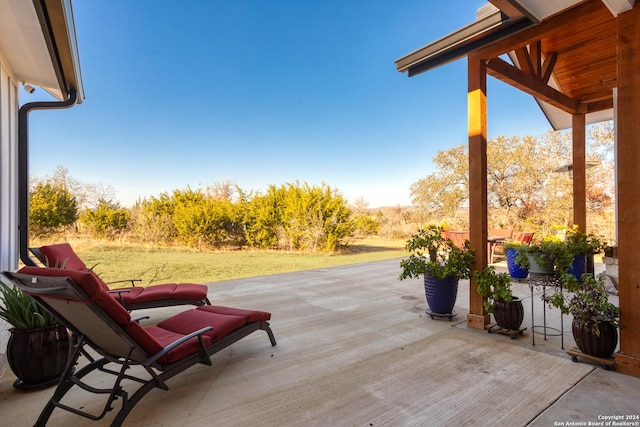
[30,122,615,252]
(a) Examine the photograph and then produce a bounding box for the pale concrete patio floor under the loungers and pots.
[0,259,640,427]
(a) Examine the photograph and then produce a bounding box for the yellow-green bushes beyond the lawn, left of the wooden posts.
[30,173,379,252]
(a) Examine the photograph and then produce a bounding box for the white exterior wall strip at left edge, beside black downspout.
[0,52,18,271]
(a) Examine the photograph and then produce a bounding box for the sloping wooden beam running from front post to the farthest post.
[487,58,586,114]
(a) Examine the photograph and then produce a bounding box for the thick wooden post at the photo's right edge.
[616,4,640,377]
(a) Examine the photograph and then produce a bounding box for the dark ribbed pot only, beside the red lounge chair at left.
[7,325,72,389]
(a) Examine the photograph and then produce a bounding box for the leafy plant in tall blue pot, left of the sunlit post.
[399,225,474,319]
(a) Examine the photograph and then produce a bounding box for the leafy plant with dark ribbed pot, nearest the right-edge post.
[545,272,621,358]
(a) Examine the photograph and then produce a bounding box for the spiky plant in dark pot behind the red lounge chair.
[0,282,71,389]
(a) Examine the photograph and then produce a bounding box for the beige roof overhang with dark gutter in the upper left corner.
[0,0,84,103]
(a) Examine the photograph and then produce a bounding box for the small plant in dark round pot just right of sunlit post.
[473,266,524,330]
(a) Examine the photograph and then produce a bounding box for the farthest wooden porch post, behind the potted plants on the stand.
[572,114,587,233]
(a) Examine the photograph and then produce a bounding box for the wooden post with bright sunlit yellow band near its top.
[467,56,491,329]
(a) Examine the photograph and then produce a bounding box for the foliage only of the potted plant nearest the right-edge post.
[544,273,622,336]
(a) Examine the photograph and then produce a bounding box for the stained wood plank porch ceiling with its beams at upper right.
[478,0,617,114]
